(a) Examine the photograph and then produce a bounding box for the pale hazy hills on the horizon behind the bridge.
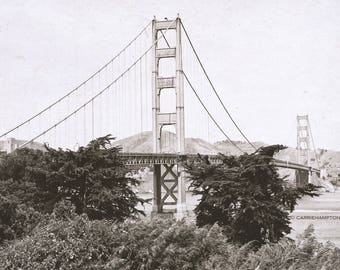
[113,131,340,178]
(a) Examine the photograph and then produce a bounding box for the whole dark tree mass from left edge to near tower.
[0,136,144,221]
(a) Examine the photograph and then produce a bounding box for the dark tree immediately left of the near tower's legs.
[26,135,144,221]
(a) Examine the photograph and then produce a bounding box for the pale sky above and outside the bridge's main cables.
[0,0,340,150]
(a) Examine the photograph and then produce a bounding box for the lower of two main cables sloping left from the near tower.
[17,21,176,148]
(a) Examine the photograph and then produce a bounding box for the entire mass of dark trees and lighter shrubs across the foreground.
[0,140,334,270]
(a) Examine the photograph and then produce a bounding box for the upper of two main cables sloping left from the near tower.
[0,21,152,139]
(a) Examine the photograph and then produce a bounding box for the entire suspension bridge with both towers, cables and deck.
[0,17,320,214]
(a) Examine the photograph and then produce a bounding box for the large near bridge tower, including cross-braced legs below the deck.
[152,17,186,217]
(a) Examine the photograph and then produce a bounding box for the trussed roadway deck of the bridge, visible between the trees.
[120,153,320,174]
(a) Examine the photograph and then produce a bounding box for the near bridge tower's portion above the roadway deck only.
[152,17,184,154]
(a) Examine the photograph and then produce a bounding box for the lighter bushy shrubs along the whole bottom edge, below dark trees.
[0,211,340,270]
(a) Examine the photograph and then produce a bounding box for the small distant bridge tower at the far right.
[296,115,311,185]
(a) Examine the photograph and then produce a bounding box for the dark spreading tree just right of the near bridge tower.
[186,145,317,244]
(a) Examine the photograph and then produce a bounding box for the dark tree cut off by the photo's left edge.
[0,148,43,244]
